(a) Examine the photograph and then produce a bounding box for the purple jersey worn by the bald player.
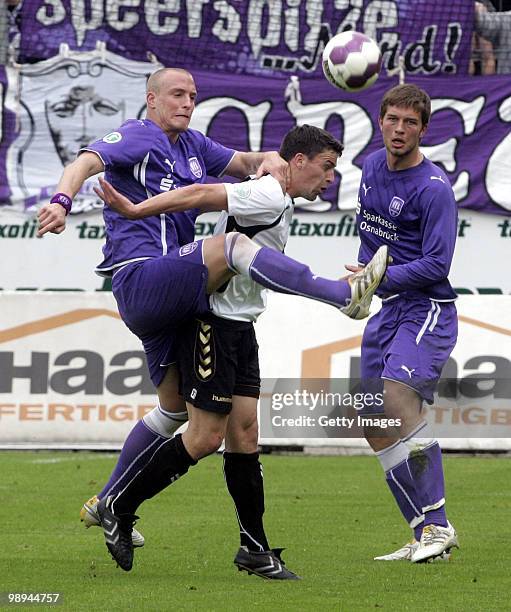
[81,119,235,276]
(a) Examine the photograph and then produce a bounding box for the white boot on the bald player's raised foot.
[341,246,389,319]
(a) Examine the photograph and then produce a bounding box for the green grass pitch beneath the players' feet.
[0,452,511,612]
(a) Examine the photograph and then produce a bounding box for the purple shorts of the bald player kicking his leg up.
[112,240,209,387]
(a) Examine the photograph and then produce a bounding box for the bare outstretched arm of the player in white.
[94,178,227,219]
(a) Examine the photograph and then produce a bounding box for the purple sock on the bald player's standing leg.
[98,421,167,499]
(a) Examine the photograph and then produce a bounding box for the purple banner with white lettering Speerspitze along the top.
[20,0,474,76]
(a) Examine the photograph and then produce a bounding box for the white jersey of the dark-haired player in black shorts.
[210,175,294,321]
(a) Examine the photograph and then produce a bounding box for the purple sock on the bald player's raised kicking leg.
[250,247,351,308]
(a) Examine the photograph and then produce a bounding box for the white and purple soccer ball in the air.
[323,30,382,91]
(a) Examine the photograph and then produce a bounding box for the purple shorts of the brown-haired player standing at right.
[360,296,458,414]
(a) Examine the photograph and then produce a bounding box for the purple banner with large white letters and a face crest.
[0,47,511,214]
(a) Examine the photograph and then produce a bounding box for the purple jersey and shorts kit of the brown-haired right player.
[357,149,457,406]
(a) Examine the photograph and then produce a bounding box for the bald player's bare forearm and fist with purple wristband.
[37,152,104,236]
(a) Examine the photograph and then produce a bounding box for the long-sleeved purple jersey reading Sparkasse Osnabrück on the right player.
[357,149,458,301]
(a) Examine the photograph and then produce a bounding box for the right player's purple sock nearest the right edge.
[407,442,447,527]
